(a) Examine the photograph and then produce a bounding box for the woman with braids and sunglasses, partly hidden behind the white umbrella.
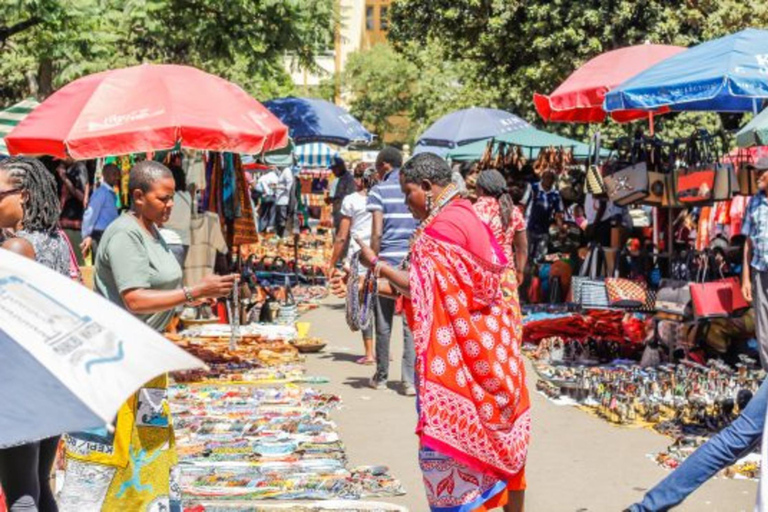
[0,158,71,512]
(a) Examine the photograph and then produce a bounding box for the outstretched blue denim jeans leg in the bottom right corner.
[628,379,768,512]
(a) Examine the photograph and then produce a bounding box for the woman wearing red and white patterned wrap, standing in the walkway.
[352,153,530,512]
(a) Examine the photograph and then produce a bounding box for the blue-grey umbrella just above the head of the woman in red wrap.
[416,107,531,148]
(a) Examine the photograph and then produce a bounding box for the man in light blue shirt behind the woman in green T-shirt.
[80,164,120,257]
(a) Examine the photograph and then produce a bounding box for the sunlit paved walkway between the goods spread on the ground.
[302,300,756,512]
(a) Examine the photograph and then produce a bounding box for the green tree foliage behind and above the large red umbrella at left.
[0,0,335,103]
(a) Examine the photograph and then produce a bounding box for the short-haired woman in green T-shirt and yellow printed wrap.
[60,161,235,511]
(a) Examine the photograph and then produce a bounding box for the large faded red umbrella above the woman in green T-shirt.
[5,64,288,159]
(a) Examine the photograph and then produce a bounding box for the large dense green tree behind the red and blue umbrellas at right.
[389,0,768,141]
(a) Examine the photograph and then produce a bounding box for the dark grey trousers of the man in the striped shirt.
[373,297,416,386]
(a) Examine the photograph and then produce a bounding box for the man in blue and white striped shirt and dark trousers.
[368,147,417,396]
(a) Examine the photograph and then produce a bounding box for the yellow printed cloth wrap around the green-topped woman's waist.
[59,375,181,512]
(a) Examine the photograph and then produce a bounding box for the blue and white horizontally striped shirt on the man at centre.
[368,169,418,265]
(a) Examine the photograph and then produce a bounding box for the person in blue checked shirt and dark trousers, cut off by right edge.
[741,164,768,370]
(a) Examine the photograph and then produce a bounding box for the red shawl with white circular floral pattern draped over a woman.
[406,201,530,477]
